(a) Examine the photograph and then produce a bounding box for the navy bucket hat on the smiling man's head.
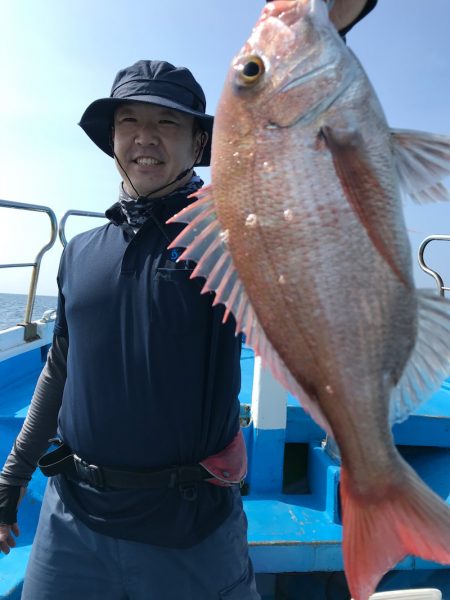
[79,60,214,166]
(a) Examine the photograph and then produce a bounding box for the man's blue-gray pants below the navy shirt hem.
[22,479,260,600]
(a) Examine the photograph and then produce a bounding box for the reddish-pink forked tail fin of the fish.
[341,459,450,600]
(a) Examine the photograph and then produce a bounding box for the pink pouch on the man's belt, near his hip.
[200,429,247,487]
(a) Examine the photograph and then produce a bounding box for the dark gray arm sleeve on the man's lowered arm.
[0,336,68,486]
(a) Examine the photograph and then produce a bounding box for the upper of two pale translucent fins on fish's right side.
[391,129,450,203]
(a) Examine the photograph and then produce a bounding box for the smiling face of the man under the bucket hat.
[113,102,201,197]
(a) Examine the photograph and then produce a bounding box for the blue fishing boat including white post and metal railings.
[0,200,450,600]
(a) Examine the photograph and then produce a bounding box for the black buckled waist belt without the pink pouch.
[38,444,213,489]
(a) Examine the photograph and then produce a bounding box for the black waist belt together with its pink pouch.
[37,430,247,489]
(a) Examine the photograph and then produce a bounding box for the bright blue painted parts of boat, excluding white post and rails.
[0,336,450,598]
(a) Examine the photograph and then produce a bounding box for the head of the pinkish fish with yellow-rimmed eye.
[214,0,354,144]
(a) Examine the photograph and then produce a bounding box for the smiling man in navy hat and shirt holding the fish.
[0,0,375,600]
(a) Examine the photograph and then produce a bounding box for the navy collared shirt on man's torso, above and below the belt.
[55,193,240,547]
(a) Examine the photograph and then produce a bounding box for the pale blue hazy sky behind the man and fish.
[0,0,450,295]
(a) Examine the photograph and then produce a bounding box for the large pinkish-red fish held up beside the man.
[170,0,450,600]
